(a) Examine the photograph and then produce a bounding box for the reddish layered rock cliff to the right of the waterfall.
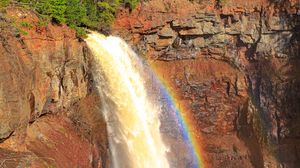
[114,0,300,167]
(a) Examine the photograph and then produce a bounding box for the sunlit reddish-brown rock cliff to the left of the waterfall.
[0,9,109,167]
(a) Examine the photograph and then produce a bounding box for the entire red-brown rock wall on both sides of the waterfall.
[0,0,300,168]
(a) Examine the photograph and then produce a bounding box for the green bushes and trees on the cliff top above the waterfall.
[6,0,138,35]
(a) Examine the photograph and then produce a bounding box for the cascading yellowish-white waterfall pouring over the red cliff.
[86,32,169,168]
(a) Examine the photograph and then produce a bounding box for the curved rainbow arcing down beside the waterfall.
[146,61,208,168]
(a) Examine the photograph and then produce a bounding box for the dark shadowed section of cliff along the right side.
[237,1,300,167]
